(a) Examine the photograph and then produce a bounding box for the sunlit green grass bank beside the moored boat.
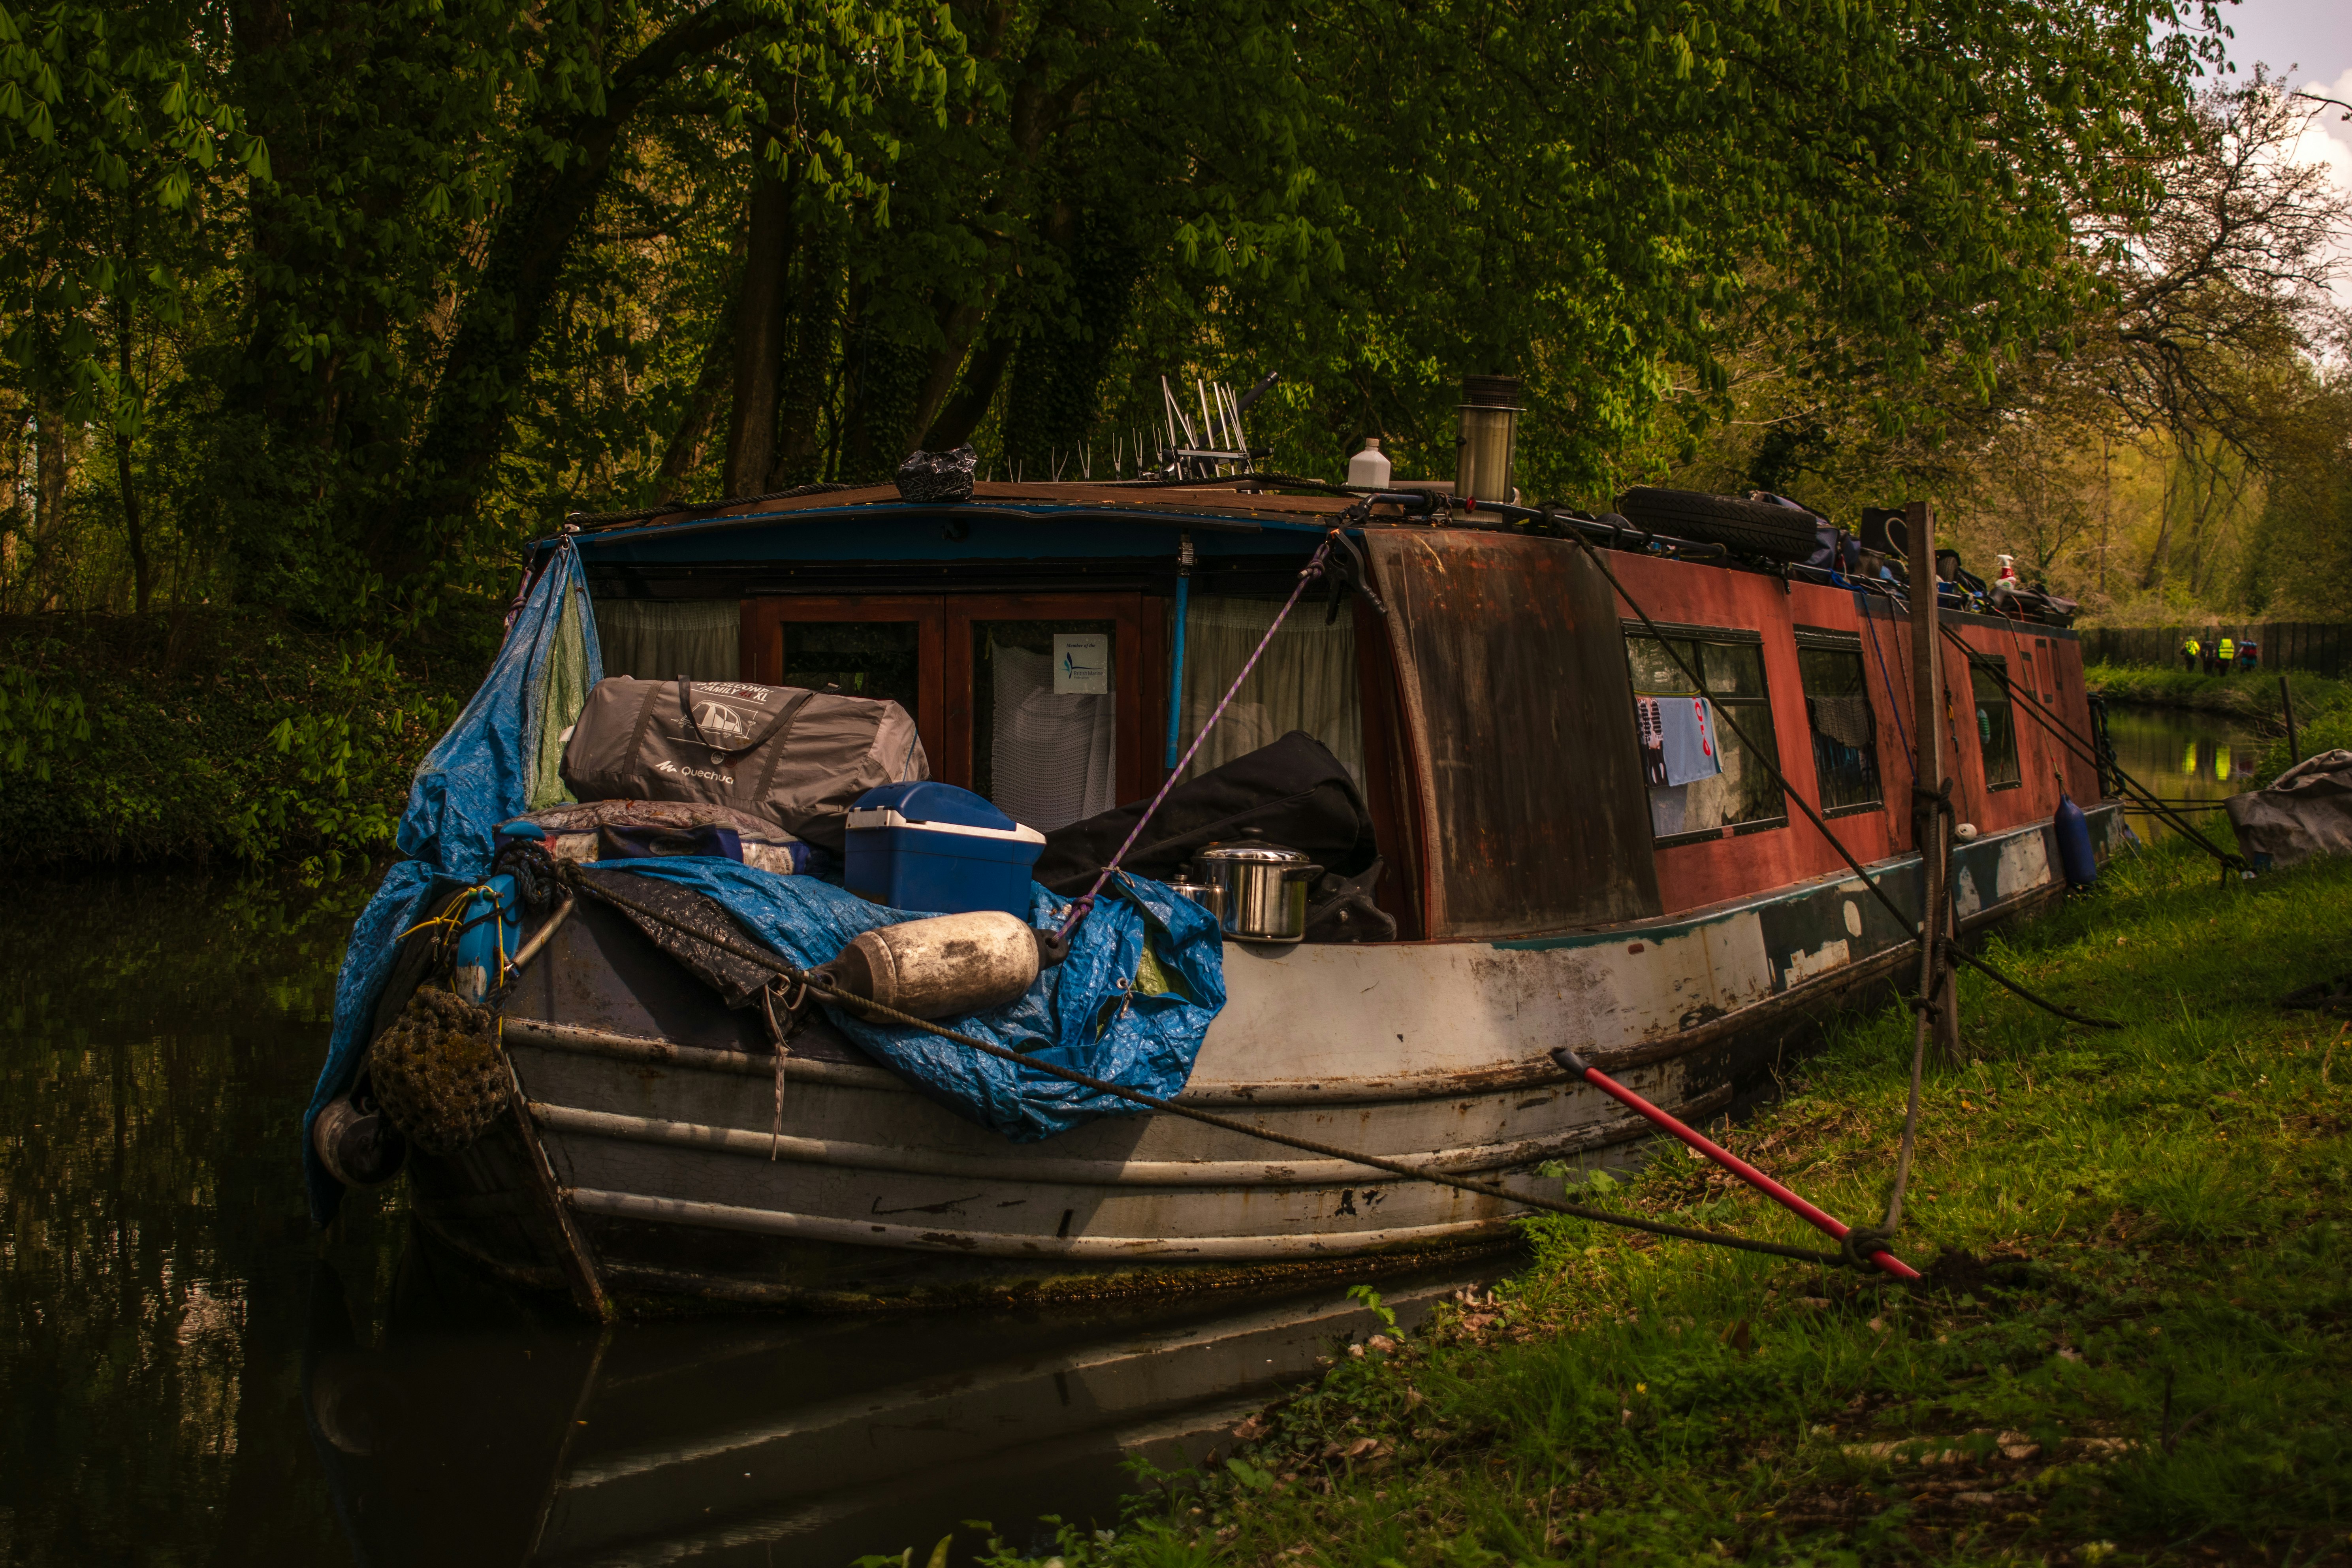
[931,844,2352,1568]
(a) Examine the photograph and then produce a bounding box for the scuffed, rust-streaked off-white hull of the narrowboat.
[416,811,2119,1305]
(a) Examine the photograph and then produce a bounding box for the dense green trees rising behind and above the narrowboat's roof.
[0,0,2249,618]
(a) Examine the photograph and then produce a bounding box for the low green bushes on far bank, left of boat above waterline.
[0,611,499,879]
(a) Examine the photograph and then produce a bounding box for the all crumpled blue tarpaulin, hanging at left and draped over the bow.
[303,543,1225,1225]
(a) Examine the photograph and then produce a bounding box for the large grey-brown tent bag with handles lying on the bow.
[562,675,931,853]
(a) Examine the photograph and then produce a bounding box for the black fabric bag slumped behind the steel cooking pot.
[1033,729,1376,898]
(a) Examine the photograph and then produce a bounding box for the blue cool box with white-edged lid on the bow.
[842,781,1044,919]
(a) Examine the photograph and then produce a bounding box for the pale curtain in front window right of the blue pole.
[1178,595,1364,787]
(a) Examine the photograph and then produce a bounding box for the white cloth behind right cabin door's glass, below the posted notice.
[988,640,1120,832]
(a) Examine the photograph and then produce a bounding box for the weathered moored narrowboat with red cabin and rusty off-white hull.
[312,465,2122,1307]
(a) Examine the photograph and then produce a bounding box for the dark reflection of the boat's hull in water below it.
[303,1237,1460,1568]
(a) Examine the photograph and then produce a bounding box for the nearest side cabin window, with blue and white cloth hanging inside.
[1625,628,1788,844]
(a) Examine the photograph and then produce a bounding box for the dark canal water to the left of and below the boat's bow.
[0,875,1508,1568]
